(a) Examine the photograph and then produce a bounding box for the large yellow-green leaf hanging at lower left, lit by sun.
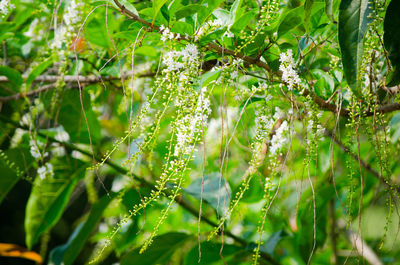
[25,160,85,249]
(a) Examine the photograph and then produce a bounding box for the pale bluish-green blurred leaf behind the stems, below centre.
[184,172,231,213]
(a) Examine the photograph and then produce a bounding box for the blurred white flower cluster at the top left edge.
[51,0,81,50]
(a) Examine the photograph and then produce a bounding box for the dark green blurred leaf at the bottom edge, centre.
[185,241,244,265]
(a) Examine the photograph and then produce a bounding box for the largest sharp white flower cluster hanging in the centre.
[174,88,211,156]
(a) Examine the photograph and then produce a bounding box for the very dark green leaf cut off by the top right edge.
[383,0,400,87]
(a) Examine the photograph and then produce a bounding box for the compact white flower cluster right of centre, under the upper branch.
[279,50,301,90]
